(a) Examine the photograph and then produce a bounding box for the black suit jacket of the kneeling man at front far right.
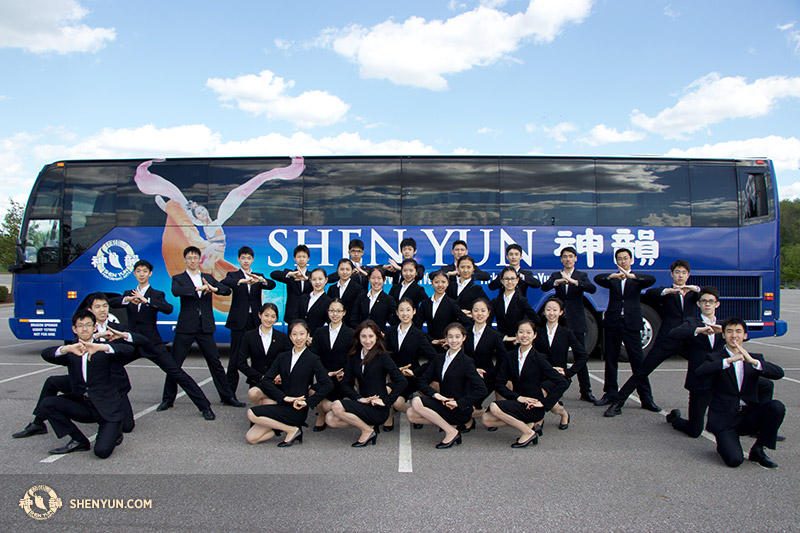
[697,350,783,433]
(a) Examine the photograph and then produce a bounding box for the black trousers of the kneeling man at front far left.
[41,396,122,459]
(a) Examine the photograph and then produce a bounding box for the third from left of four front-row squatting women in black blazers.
[406,322,488,449]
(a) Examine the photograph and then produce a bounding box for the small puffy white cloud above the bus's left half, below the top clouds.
[206,70,350,128]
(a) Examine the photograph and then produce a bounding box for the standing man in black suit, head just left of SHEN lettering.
[222,246,275,398]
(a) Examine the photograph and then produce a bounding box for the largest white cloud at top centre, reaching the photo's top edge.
[317,0,592,91]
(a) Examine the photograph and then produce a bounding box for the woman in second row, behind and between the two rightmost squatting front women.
[464,298,506,424]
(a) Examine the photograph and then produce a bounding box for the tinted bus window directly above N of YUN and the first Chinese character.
[500,160,597,226]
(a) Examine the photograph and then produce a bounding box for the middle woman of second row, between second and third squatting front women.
[383,298,436,431]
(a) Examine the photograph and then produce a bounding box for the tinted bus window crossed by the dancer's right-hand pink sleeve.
[208,157,303,226]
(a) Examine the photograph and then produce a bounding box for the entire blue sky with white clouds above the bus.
[0,0,800,216]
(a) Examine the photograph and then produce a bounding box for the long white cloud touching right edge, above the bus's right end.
[631,72,800,139]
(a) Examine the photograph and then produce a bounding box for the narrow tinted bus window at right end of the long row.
[690,164,738,227]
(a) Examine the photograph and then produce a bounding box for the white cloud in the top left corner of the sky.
[0,0,117,54]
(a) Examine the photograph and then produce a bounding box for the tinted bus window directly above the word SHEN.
[303,158,402,226]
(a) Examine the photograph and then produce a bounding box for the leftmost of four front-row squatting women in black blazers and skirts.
[245,320,333,448]
